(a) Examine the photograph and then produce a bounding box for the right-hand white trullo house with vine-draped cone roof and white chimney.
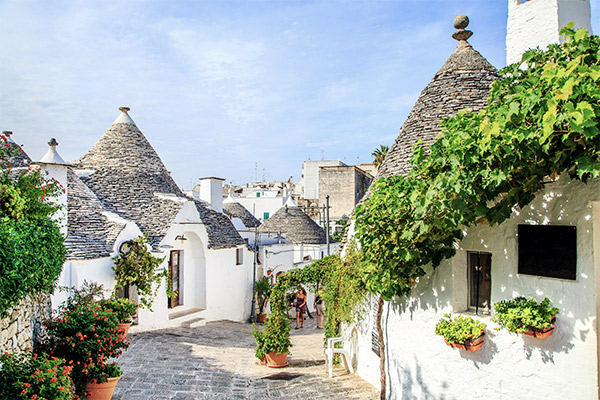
[347,4,600,399]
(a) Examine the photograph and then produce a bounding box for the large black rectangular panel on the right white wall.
[517,225,577,280]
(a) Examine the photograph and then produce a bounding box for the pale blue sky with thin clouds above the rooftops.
[0,0,600,189]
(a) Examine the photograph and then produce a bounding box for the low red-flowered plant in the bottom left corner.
[0,350,76,400]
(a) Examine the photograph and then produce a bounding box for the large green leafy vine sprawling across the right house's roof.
[355,24,600,300]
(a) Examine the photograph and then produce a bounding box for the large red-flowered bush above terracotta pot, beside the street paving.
[38,303,128,396]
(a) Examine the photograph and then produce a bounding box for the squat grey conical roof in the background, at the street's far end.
[258,199,332,244]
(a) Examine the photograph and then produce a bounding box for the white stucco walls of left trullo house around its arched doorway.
[52,196,253,332]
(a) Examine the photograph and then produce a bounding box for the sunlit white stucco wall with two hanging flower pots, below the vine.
[357,178,600,400]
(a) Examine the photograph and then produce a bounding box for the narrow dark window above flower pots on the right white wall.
[467,251,492,314]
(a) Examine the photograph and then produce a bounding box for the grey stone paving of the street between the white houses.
[113,319,379,400]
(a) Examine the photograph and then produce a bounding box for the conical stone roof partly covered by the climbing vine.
[376,31,498,179]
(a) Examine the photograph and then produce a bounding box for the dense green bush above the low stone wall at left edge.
[0,135,66,317]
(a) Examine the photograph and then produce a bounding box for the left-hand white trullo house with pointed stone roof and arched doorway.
[48,107,253,331]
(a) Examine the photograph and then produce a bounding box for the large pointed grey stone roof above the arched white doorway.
[76,107,245,248]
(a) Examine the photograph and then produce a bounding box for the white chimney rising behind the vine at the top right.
[506,0,592,64]
